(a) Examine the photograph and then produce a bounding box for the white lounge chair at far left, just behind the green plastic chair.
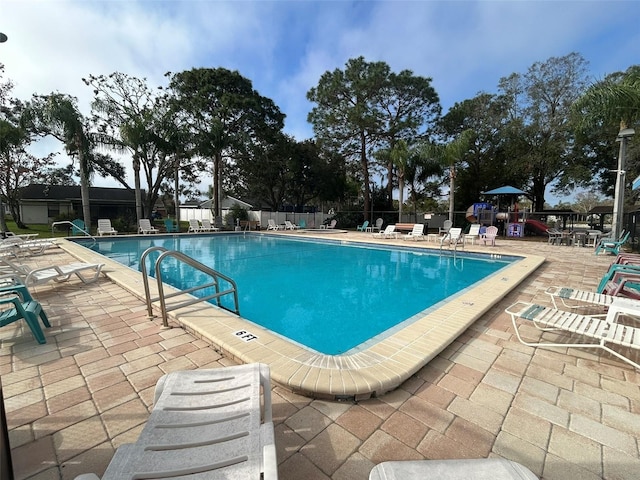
[0,257,104,287]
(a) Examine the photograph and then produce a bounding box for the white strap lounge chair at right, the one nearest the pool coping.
[505,302,640,370]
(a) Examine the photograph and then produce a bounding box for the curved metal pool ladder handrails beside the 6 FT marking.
[140,246,240,328]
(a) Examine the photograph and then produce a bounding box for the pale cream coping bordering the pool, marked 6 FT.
[59,232,545,400]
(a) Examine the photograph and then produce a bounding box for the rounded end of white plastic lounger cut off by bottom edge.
[369,458,538,480]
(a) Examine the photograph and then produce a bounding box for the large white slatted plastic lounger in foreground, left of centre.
[76,364,278,480]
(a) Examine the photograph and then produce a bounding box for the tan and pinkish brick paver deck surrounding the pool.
[0,232,640,480]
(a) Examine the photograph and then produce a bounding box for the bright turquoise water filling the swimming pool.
[79,234,514,355]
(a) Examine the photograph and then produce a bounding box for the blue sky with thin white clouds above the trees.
[0,0,640,200]
